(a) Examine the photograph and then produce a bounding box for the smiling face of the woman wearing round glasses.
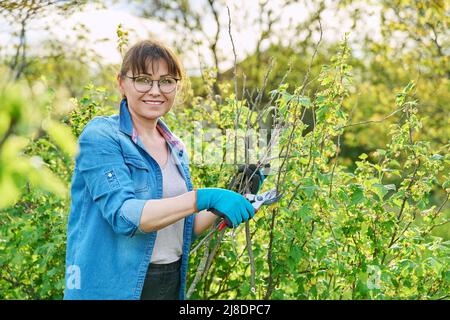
[118,59,177,120]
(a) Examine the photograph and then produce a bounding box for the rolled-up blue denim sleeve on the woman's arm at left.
[76,118,147,236]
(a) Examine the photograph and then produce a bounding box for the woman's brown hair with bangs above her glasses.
[119,40,189,101]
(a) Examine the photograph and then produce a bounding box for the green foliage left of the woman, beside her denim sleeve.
[0,85,115,299]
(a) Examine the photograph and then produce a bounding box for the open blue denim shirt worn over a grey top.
[64,100,196,300]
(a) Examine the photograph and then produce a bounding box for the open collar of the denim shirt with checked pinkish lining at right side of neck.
[119,99,185,152]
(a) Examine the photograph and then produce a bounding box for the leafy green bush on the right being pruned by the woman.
[185,37,450,299]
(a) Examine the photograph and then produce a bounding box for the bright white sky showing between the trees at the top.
[0,0,379,74]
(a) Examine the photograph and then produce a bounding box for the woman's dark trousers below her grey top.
[141,258,181,300]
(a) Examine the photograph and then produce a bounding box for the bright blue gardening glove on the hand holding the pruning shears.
[195,188,255,228]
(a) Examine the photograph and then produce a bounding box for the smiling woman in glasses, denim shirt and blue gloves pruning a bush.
[64,40,254,299]
